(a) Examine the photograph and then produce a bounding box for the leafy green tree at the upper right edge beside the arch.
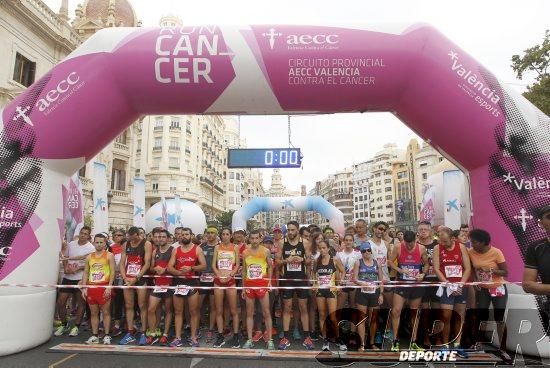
[512,30,550,115]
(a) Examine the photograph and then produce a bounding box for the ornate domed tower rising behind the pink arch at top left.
[73,0,141,39]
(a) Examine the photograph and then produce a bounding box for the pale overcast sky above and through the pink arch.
[44,0,550,190]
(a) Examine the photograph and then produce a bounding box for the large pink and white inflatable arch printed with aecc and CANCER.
[0,25,550,355]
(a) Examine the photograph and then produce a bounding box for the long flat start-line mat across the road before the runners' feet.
[49,343,501,366]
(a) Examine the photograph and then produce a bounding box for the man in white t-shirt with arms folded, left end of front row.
[54,226,95,336]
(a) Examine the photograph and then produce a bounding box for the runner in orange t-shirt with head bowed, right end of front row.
[468,229,512,362]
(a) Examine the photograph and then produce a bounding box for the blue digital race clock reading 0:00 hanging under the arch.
[227,148,302,168]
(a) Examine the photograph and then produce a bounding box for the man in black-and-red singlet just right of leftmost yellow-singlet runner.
[119,226,152,345]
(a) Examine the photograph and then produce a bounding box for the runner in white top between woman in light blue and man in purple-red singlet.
[369,221,394,341]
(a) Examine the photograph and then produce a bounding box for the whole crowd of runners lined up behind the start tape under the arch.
[54,210,550,359]
